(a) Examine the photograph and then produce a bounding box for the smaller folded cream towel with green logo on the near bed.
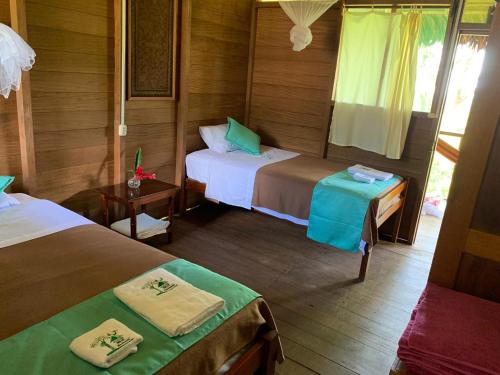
[69,319,143,368]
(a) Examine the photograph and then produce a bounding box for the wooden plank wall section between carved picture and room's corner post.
[186,0,253,151]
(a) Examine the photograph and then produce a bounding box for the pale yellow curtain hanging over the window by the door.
[330,10,422,159]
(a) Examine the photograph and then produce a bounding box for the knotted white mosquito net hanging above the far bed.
[279,0,338,52]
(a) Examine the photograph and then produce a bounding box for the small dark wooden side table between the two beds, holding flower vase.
[99,180,180,243]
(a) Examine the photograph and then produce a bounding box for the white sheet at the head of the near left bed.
[0,194,94,248]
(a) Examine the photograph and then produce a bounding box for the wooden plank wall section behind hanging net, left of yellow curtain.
[249,6,341,157]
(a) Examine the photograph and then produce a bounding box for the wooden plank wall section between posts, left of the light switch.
[26,0,113,216]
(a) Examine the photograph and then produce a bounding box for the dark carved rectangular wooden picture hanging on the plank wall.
[127,0,177,100]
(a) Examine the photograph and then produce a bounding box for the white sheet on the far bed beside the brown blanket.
[186,146,309,226]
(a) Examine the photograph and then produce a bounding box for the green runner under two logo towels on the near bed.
[0,259,260,375]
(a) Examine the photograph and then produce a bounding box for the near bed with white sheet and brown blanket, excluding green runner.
[0,194,283,374]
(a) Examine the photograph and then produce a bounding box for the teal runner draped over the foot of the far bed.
[307,170,401,253]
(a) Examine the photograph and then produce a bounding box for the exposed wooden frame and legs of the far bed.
[181,178,410,281]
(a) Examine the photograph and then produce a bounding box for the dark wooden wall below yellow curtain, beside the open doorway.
[327,113,438,243]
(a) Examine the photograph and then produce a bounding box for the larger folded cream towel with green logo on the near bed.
[113,268,224,337]
